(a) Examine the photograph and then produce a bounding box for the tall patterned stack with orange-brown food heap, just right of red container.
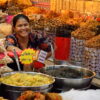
[70,28,96,66]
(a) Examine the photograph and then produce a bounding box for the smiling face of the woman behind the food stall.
[14,18,30,37]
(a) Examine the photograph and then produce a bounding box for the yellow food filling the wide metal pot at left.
[0,73,54,87]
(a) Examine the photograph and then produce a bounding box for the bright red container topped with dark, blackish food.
[54,24,77,62]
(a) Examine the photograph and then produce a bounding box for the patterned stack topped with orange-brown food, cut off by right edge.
[84,35,100,78]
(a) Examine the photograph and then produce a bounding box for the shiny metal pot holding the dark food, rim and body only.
[41,65,95,90]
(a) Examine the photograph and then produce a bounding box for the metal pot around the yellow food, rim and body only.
[1,71,55,100]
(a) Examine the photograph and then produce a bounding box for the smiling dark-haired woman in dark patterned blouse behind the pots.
[6,14,51,70]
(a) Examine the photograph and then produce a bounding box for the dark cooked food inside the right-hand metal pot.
[44,67,90,78]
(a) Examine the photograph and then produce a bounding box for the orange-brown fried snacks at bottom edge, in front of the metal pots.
[17,91,62,100]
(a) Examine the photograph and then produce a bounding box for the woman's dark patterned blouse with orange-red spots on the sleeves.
[6,33,51,52]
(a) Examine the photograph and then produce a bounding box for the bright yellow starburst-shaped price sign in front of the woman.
[19,49,37,64]
